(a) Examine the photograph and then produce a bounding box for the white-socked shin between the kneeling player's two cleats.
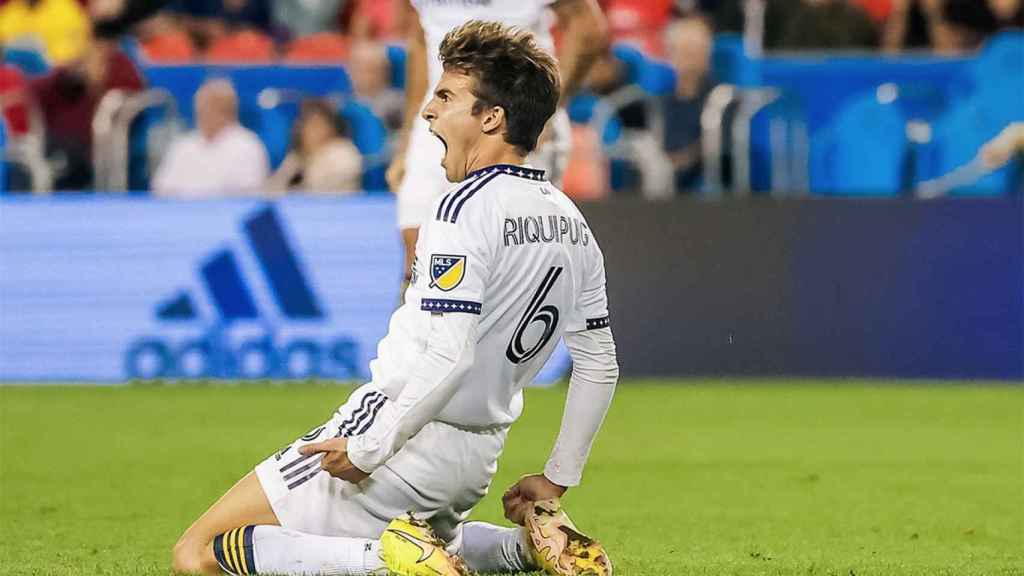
[458,522,539,574]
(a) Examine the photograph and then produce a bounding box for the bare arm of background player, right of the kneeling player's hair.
[551,0,608,105]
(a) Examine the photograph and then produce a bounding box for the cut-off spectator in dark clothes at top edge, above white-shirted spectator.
[172,0,270,49]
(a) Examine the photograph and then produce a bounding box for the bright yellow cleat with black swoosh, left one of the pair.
[381,513,469,576]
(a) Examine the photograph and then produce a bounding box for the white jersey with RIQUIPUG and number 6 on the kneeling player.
[349,165,608,469]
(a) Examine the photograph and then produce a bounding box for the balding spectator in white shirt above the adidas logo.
[153,79,269,198]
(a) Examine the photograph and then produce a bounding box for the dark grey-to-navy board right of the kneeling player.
[583,194,1024,379]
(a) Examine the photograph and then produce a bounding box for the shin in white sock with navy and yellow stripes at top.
[213,526,384,576]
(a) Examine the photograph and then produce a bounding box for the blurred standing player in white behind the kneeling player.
[387,0,608,291]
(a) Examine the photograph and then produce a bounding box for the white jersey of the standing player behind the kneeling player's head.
[413,0,555,87]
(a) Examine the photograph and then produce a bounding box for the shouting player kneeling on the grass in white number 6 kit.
[173,22,618,576]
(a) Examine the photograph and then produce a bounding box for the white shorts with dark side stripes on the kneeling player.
[256,384,507,541]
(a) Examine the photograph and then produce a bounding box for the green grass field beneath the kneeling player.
[0,381,1024,576]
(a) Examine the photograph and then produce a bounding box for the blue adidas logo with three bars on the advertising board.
[124,205,361,379]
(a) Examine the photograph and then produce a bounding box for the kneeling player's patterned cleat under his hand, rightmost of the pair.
[526,499,611,576]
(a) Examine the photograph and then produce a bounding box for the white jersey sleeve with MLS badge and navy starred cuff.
[417,192,496,315]
